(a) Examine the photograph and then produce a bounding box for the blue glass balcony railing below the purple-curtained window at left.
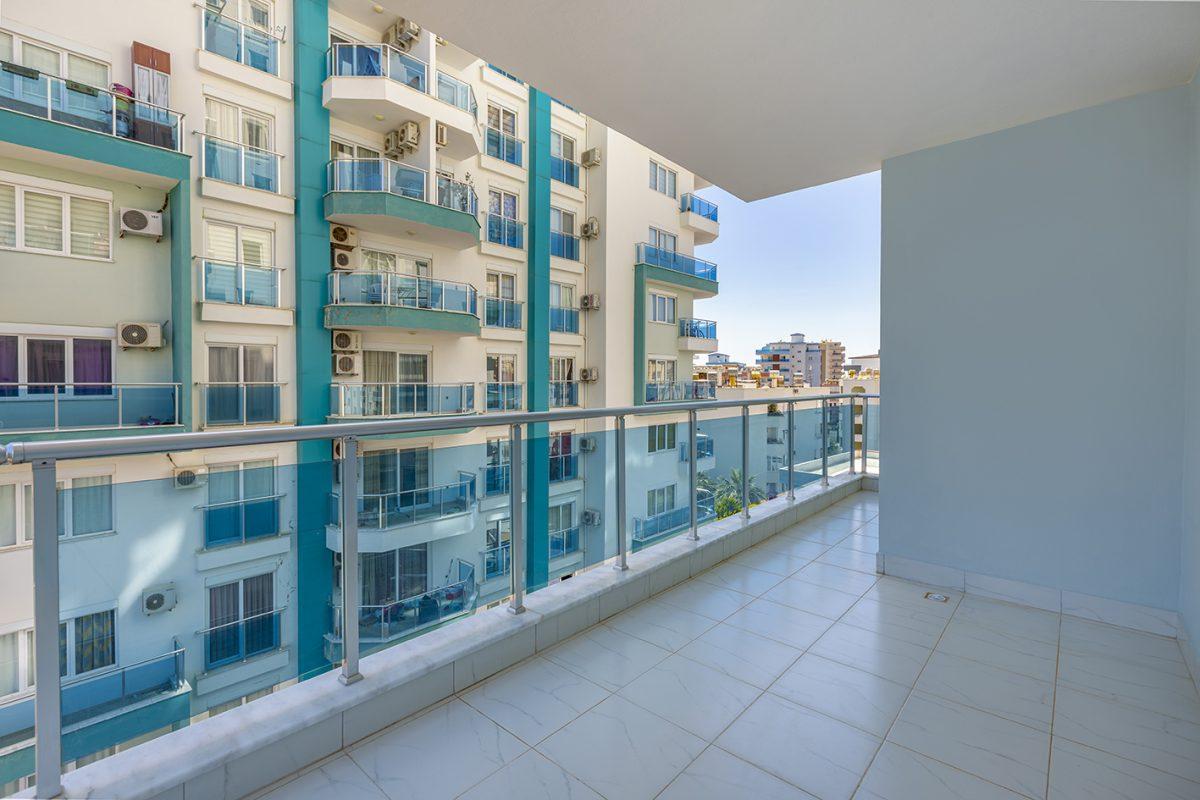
[0,383,181,435]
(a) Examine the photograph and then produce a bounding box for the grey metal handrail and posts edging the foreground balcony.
[4,384,878,796]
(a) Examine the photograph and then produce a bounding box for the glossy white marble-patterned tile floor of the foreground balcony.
[253,493,1200,800]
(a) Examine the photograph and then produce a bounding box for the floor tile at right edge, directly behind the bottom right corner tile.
[1054,685,1200,783]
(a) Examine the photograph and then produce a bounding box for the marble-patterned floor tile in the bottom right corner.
[1050,736,1200,800]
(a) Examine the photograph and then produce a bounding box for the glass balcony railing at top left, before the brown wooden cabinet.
[0,68,184,152]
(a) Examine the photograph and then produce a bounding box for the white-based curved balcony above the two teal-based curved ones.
[322,43,484,161]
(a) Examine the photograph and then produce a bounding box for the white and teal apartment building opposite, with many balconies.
[0,0,719,793]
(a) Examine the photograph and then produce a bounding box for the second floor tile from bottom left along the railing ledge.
[350,698,527,800]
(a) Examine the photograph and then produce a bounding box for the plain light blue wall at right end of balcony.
[880,88,1195,609]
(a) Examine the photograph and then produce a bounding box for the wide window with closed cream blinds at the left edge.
[0,182,113,259]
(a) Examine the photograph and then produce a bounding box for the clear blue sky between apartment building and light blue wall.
[695,173,880,361]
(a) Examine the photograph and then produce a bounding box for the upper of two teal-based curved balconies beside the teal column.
[324,158,479,249]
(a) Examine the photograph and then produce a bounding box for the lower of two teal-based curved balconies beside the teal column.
[325,271,479,336]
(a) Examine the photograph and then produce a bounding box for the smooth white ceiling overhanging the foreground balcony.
[378,0,1200,200]
